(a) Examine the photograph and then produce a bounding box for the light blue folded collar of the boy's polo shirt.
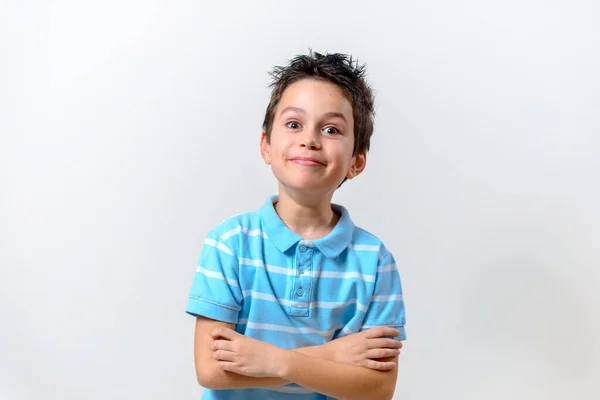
[258,196,355,258]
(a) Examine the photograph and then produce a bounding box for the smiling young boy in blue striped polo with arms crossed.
[186,51,406,400]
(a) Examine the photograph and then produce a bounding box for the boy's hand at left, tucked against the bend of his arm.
[210,327,286,378]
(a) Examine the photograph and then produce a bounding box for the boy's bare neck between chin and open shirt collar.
[274,190,340,240]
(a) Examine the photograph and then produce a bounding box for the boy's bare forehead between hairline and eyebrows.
[277,79,352,119]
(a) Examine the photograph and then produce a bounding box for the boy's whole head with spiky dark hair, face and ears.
[261,51,374,194]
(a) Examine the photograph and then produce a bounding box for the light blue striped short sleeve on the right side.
[361,250,406,340]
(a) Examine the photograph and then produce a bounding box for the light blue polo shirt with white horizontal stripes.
[185,196,406,400]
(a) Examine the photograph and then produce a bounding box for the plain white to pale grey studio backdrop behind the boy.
[0,0,600,400]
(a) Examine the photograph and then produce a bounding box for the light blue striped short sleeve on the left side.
[185,231,243,324]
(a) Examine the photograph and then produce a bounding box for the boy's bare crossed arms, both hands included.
[194,316,402,400]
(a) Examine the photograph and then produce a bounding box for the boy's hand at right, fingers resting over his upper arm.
[323,326,402,371]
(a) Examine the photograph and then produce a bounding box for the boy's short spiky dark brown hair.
[263,50,375,155]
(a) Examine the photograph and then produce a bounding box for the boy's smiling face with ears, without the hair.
[260,79,366,195]
